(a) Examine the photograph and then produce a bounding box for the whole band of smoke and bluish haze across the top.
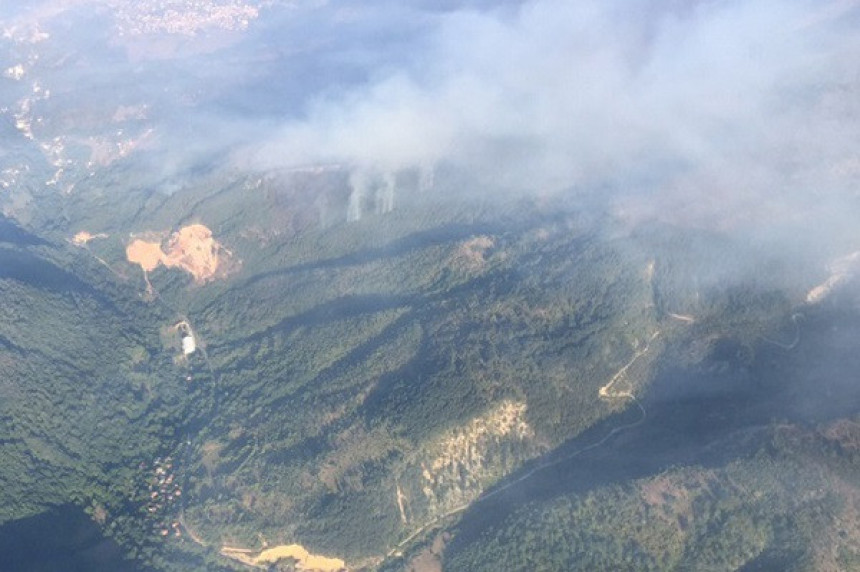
[5,0,860,239]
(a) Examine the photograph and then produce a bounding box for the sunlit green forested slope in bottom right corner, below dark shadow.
[446,426,860,570]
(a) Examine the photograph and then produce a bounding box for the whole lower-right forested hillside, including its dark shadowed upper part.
[445,298,860,570]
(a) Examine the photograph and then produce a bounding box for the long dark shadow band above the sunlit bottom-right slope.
[449,302,860,554]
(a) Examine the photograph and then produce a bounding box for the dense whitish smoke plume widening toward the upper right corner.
[244,0,860,232]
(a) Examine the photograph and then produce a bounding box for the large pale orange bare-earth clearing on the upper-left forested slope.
[125,224,230,283]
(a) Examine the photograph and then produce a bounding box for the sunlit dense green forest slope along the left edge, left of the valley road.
[0,225,225,563]
